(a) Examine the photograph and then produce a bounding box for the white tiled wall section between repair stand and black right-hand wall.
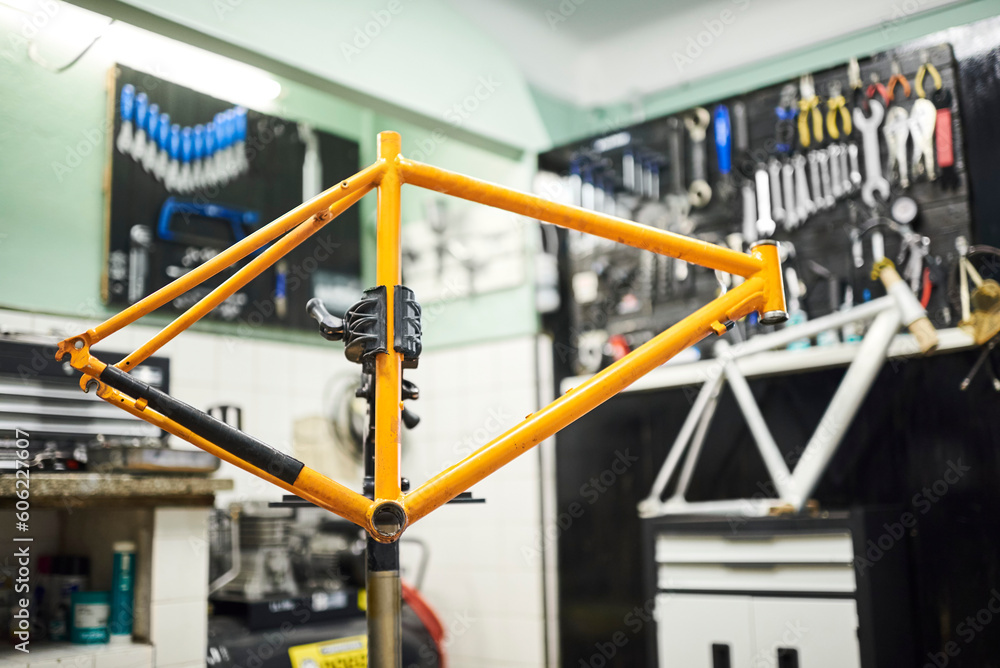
[403,337,545,668]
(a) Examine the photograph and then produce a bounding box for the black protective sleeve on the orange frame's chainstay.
[101,365,303,485]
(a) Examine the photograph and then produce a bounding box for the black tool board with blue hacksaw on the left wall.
[102,65,361,329]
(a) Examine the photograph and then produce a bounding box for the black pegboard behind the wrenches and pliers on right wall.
[538,44,973,371]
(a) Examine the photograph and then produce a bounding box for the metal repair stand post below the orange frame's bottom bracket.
[366,536,403,668]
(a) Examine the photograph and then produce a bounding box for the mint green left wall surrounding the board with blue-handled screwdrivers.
[0,6,536,348]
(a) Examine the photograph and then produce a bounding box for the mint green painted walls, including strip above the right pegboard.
[0,0,1000,348]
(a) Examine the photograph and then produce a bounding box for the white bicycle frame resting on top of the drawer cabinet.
[639,286,940,517]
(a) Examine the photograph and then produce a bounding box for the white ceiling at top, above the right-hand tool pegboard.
[450,0,956,107]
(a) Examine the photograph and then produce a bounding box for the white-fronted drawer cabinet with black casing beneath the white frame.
[646,511,912,668]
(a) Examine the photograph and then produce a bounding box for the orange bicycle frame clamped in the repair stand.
[57,132,785,543]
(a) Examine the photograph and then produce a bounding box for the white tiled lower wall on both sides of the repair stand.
[0,310,545,668]
